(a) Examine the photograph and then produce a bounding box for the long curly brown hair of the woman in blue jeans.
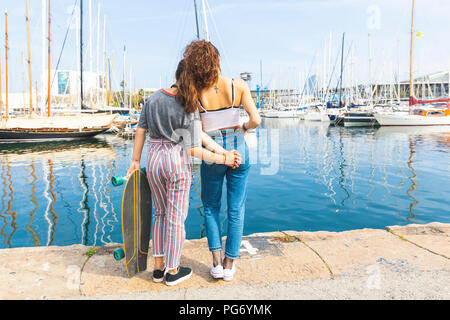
[177,40,220,113]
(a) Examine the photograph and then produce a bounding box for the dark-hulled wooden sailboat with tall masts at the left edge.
[0,0,117,142]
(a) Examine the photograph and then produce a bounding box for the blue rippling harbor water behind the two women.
[0,118,450,248]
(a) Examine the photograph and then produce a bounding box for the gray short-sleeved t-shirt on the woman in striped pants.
[138,90,202,148]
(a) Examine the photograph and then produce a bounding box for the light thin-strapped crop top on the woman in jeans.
[199,79,240,132]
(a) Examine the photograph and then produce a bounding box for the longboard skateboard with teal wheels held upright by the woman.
[111,168,152,278]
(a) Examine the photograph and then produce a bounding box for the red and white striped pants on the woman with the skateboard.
[146,138,192,270]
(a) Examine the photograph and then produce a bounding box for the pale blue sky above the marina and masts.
[0,0,450,92]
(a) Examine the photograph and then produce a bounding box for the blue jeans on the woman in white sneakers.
[200,129,250,259]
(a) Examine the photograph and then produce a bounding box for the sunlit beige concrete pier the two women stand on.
[0,223,450,300]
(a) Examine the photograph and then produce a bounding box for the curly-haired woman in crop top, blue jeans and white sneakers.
[178,40,261,281]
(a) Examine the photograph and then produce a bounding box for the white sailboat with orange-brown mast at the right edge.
[374,0,450,126]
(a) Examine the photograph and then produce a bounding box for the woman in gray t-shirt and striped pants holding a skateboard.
[128,60,240,286]
